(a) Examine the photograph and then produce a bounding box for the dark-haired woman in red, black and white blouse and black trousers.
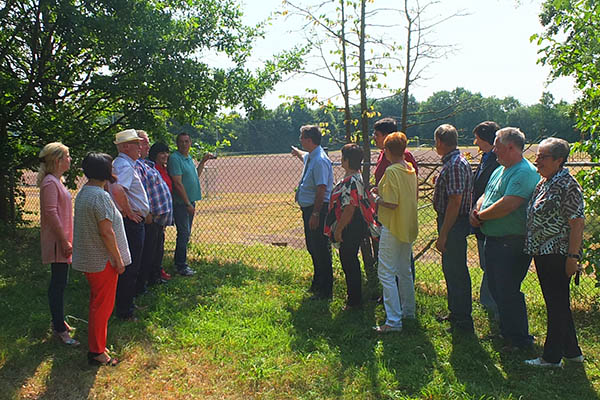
[325,143,378,310]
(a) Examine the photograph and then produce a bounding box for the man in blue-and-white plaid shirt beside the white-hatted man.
[135,130,173,295]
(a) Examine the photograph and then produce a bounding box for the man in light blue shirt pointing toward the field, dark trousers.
[292,125,333,299]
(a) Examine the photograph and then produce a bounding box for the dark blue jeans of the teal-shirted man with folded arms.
[485,236,533,347]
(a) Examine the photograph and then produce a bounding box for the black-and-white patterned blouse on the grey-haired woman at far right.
[525,168,584,256]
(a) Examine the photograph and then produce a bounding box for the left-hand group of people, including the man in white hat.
[37,129,214,366]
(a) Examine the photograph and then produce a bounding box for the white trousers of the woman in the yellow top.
[377,226,415,327]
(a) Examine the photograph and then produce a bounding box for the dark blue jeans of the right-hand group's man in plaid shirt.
[437,214,473,330]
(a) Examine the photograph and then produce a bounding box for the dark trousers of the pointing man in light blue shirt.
[302,203,333,297]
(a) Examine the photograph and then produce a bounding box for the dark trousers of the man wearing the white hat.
[115,218,145,318]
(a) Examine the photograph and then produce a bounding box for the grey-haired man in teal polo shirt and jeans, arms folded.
[470,128,540,349]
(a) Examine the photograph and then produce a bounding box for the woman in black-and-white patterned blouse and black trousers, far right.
[525,138,584,367]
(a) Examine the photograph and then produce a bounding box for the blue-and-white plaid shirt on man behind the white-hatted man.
[135,158,173,226]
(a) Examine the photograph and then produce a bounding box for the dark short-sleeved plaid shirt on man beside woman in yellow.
[433,149,473,215]
